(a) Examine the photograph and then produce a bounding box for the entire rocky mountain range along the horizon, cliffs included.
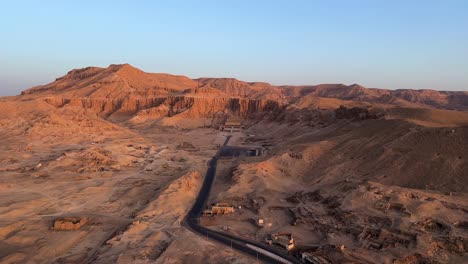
[19,64,468,124]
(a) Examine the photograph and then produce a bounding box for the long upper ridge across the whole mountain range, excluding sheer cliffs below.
[18,64,468,111]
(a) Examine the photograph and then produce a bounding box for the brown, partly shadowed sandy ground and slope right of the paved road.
[202,120,468,263]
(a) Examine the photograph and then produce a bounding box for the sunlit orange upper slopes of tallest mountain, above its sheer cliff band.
[22,64,282,100]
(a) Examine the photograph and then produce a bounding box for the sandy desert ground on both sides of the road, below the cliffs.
[0,95,468,263]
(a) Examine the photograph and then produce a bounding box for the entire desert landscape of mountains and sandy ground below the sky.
[0,64,468,264]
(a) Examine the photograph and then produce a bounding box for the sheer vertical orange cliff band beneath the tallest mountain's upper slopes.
[44,96,283,119]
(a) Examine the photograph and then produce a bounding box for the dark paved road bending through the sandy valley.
[182,136,301,263]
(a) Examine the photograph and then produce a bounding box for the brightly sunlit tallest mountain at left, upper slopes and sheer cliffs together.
[22,64,288,121]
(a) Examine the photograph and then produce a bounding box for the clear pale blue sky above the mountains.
[0,0,468,95]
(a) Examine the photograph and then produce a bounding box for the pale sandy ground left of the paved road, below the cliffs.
[0,108,250,263]
